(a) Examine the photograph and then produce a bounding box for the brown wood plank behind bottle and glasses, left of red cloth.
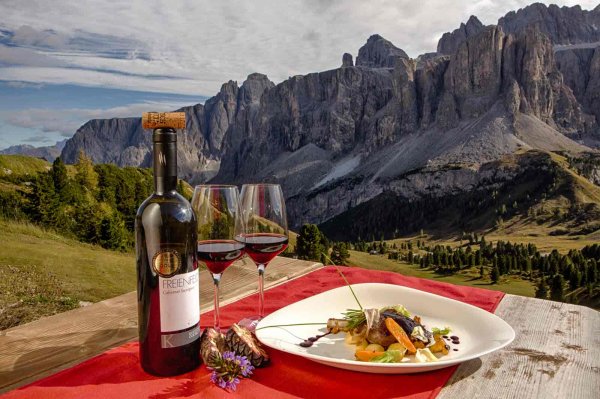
[0,257,322,392]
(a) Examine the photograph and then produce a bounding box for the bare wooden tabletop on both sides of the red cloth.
[0,258,600,398]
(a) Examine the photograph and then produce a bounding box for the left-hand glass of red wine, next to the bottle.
[192,185,244,331]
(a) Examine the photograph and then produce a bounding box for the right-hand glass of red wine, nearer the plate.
[240,184,288,330]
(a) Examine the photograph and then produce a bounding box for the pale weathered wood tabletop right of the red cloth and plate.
[439,295,600,399]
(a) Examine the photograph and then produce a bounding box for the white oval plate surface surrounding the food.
[256,283,515,374]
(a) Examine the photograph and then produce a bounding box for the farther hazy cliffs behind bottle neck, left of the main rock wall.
[61,74,273,183]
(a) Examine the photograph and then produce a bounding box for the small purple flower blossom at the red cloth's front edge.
[207,351,254,391]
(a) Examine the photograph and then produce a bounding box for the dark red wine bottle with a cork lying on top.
[135,113,200,376]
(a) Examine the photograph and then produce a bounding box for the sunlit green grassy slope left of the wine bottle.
[0,219,135,330]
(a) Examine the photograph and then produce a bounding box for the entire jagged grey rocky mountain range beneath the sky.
[63,4,600,238]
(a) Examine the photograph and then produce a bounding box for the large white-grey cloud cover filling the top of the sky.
[0,0,596,95]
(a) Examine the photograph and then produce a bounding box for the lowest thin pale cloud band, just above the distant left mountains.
[0,102,195,137]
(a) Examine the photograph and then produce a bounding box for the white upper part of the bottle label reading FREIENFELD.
[158,269,200,333]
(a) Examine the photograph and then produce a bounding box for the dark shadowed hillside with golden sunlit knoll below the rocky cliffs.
[319,151,600,242]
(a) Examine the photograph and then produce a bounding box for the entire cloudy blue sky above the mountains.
[0,0,597,149]
